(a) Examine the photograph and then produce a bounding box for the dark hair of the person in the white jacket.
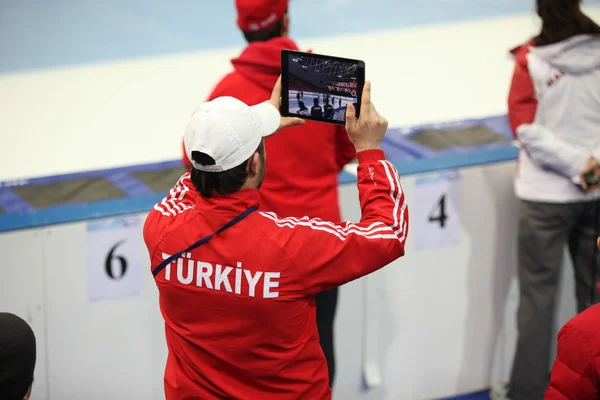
[534,0,600,46]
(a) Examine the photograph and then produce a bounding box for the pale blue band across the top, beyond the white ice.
[0,0,600,73]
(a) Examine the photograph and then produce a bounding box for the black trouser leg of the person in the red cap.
[315,288,338,387]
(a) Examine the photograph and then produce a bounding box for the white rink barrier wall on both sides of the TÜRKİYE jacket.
[0,163,574,400]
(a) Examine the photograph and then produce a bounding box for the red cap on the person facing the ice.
[235,0,289,32]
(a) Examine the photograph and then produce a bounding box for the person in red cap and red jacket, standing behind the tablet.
[183,0,356,385]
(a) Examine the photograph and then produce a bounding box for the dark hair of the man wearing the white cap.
[191,139,265,198]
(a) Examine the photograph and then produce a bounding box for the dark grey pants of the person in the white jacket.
[508,201,598,400]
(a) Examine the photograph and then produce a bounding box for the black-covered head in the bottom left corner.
[0,312,36,400]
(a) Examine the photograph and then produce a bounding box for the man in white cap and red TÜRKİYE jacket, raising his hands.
[150,81,408,400]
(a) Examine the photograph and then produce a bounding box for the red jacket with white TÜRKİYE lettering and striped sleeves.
[144,150,408,400]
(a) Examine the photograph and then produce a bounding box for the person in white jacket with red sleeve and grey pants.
[492,0,600,400]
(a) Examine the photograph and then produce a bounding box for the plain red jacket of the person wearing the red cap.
[183,38,356,222]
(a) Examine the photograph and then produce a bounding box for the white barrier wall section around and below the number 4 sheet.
[356,163,517,399]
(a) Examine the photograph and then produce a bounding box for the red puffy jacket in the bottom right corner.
[544,304,600,400]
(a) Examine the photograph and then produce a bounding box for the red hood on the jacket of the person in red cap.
[231,37,298,91]
